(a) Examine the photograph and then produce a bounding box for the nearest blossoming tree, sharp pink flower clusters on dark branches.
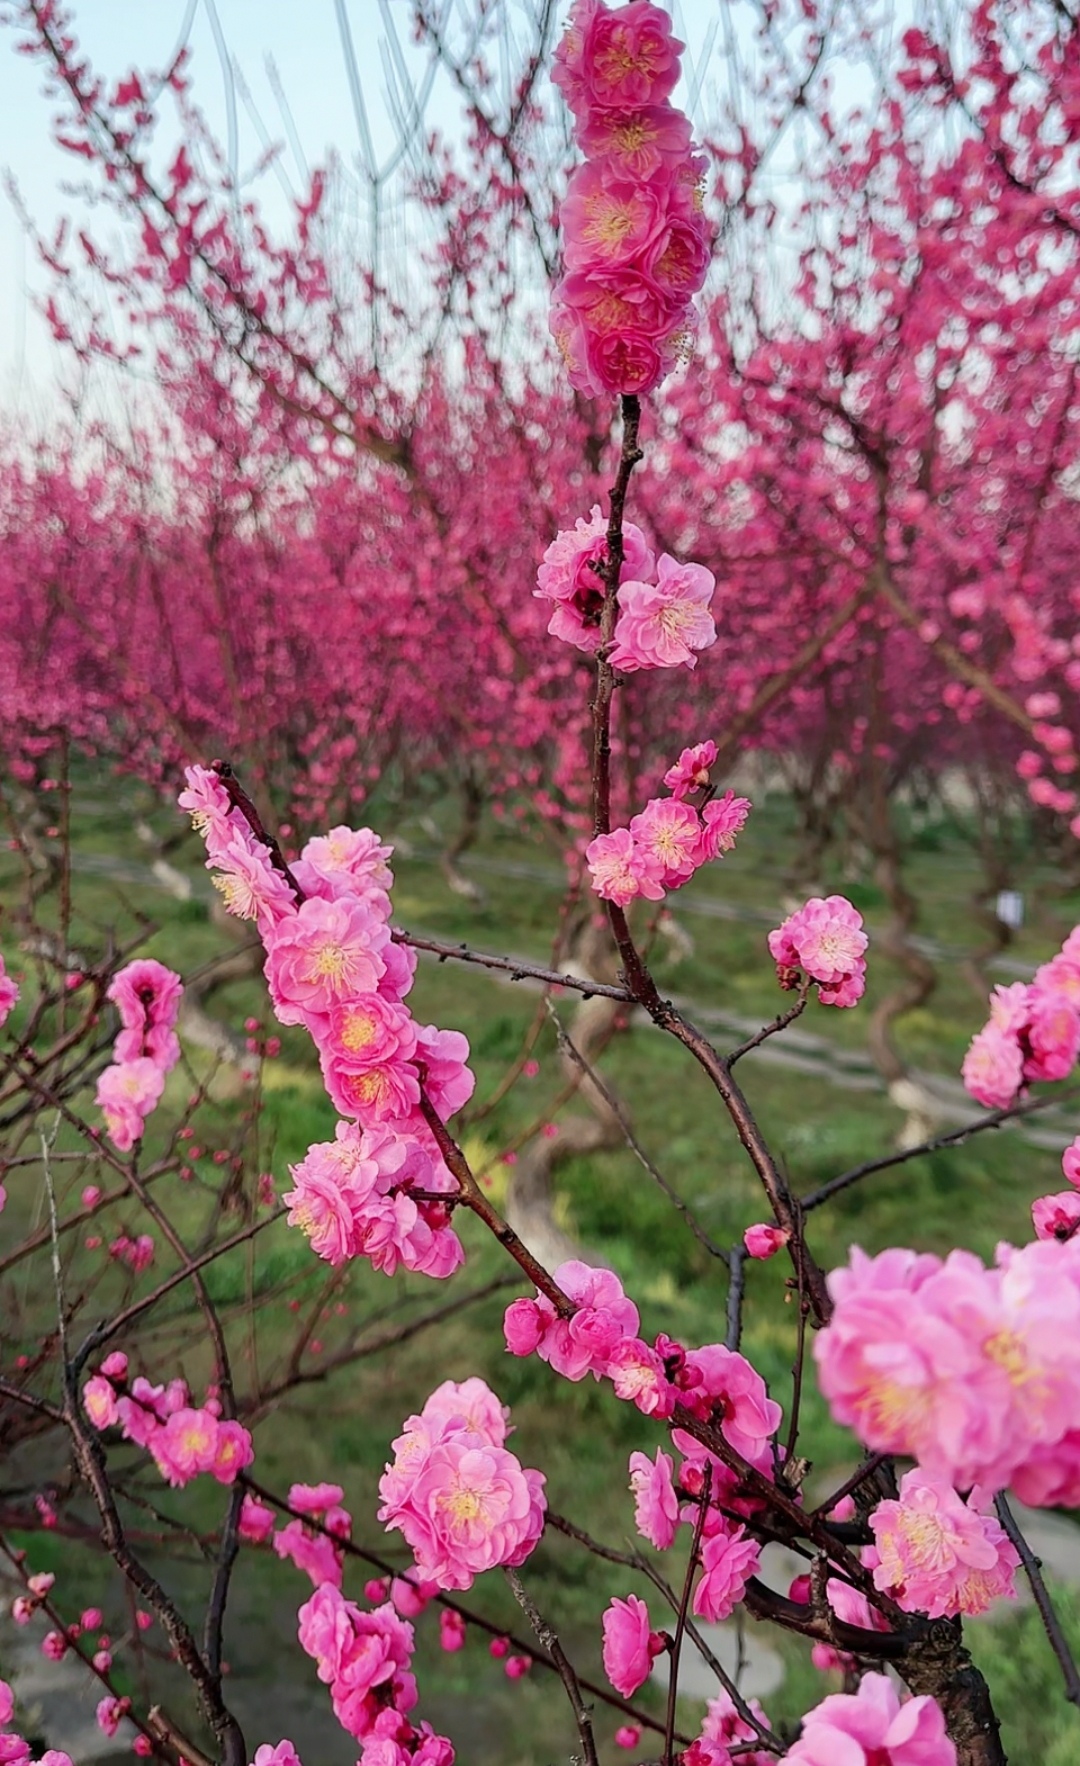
[0,0,1080,1766]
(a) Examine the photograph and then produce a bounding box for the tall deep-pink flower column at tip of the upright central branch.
[551,0,711,397]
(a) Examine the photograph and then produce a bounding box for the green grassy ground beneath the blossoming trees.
[0,777,1080,1766]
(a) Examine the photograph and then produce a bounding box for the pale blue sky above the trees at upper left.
[0,0,734,422]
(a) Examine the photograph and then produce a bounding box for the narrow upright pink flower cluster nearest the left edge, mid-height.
[97,957,184,1153]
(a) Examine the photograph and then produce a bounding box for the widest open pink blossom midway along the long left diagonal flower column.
[266,895,390,1024]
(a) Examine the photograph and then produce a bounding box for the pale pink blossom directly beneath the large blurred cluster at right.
[870,1466,1020,1619]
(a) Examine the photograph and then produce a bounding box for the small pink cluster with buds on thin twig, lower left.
[83,1351,254,1485]
